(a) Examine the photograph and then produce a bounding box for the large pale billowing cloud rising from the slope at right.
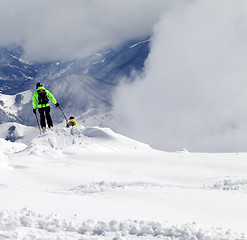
[113,0,247,152]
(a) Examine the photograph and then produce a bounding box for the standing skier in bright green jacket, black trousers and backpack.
[33,83,59,132]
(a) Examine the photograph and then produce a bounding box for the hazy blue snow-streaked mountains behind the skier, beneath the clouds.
[0,38,150,125]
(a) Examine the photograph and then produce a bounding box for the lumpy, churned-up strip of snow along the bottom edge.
[0,208,245,240]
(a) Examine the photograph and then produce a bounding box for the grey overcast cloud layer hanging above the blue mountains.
[0,0,170,62]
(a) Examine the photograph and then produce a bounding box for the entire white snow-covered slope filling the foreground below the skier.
[0,126,247,240]
